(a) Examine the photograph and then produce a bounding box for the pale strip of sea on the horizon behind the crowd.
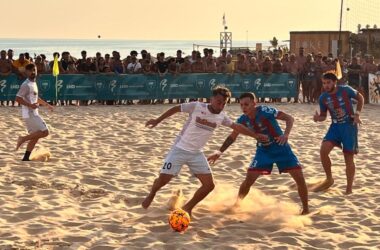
[0,38,270,60]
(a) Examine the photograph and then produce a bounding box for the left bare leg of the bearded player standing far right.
[314,141,334,192]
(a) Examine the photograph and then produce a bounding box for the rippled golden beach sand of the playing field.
[0,104,380,249]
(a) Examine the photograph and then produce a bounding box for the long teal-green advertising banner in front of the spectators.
[0,74,297,101]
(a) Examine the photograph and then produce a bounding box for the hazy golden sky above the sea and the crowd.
[0,0,380,40]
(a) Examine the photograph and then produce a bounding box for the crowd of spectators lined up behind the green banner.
[0,48,380,104]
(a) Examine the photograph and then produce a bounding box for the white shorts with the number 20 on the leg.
[160,146,211,175]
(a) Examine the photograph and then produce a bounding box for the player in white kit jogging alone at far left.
[16,64,53,161]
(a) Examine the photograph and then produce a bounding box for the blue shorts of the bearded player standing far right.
[323,122,359,154]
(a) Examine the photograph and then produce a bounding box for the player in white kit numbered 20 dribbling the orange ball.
[141,87,268,215]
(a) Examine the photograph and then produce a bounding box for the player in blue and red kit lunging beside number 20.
[208,93,309,214]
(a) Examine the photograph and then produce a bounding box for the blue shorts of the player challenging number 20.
[248,143,301,174]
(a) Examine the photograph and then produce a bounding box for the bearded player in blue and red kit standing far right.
[314,73,364,194]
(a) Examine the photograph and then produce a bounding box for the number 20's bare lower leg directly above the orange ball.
[182,174,215,216]
